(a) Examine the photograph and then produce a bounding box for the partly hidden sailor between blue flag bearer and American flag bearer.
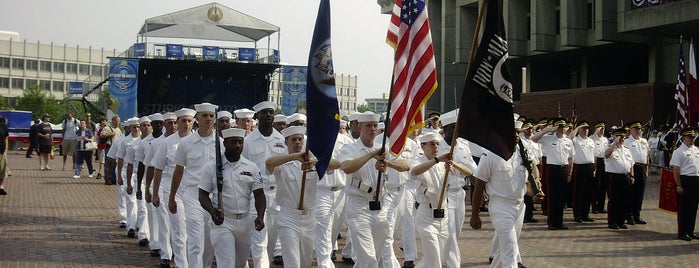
[313,127,354,268]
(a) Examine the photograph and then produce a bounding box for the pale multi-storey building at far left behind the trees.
[0,31,120,98]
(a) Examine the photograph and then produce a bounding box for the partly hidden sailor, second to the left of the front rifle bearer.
[151,108,196,268]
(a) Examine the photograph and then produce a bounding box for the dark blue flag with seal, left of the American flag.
[306,0,340,179]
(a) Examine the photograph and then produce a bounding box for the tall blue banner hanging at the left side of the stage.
[108,58,138,120]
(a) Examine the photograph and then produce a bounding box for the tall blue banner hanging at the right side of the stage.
[281,66,308,115]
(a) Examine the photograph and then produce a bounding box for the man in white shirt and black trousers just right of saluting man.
[569,121,595,222]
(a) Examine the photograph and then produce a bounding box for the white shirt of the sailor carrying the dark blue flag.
[272,161,318,210]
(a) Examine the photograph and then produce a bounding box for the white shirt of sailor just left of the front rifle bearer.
[175,131,223,186]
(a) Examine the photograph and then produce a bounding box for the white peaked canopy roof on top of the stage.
[139,3,279,42]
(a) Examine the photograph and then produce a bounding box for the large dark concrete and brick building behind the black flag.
[377,0,699,125]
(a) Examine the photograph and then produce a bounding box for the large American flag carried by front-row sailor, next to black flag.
[386,0,437,155]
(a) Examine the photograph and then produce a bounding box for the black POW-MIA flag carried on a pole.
[457,0,515,159]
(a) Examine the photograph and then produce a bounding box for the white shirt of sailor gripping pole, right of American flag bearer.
[411,155,446,204]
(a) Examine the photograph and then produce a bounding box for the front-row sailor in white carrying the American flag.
[338,112,410,267]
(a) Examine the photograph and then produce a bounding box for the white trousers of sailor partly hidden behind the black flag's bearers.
[446,187,466,267]
